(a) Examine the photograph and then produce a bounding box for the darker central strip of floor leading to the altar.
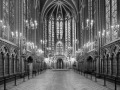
[45,71,74,90]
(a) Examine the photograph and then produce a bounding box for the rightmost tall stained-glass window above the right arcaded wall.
[105,0,119,43]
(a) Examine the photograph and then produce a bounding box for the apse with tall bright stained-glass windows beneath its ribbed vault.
[43,0,76,57]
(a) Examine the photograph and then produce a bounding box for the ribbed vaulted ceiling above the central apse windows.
[40,0,79,21]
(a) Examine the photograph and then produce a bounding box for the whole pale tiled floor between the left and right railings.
[0,70,120,90]
